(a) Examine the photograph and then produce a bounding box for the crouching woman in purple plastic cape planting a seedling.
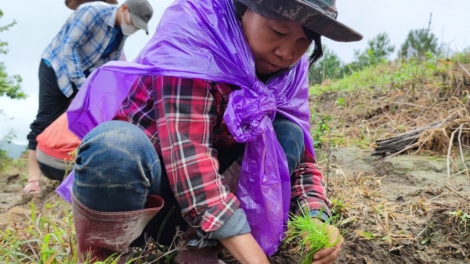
[63,0,362,263]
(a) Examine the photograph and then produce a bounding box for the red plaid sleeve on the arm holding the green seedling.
[291,150,332,215]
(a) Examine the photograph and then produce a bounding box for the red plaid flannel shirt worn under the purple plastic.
[114,76,330,232]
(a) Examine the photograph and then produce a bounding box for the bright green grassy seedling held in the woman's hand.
[286,210,339,264]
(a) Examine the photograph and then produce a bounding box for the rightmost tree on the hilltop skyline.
[398,28,442,59]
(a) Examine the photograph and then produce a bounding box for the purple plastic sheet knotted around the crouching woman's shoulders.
[58,0,314,255]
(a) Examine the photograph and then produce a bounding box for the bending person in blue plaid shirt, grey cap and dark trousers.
[23,0,153,194]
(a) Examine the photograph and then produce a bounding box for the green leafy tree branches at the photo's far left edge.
[0,10,26,99]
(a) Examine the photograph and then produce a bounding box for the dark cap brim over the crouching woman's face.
[238,0,363,42]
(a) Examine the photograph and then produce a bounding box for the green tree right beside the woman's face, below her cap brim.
[309,45,343,84]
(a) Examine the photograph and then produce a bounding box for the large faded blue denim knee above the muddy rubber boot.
[73,121,161,212]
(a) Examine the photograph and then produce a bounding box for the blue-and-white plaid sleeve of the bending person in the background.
[63,8,100,88]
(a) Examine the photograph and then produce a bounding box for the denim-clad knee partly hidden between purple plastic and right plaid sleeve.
[273,115,305,175]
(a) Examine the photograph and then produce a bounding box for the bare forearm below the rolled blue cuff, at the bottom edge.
[220,233,269,264]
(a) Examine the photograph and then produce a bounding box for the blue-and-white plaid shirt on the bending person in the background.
[42,2,127,97]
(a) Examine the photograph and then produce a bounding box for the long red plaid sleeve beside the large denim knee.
[153,77,239,232]
